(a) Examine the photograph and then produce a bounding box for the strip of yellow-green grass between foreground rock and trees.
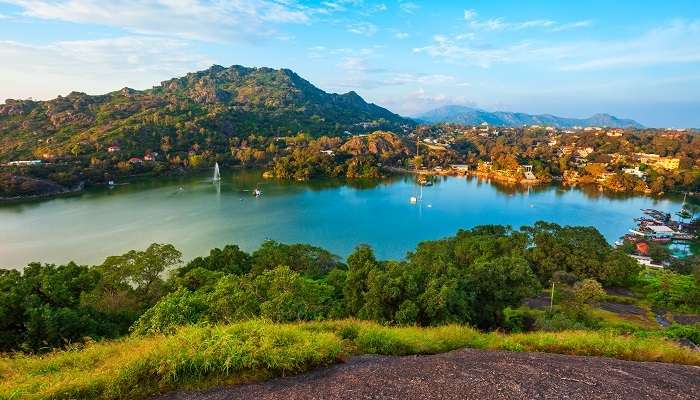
[0,320,700,399]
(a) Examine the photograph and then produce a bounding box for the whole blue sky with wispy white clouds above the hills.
[0,0,700,127]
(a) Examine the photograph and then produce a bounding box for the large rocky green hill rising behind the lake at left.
[0,65,412,161]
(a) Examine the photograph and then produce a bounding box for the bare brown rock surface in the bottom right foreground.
[157,349,700,400]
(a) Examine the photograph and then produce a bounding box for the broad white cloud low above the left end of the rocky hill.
[0,36,212,98]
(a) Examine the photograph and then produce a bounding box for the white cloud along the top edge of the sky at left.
[4,0,314,42]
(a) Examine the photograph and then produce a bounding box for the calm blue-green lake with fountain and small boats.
[0,171,682,268]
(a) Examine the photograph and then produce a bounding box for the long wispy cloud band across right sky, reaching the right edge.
[413,21,700,71]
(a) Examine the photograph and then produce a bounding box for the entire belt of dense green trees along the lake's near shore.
[0,222,660,351]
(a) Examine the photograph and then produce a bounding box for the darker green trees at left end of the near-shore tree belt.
[0,244,180,351]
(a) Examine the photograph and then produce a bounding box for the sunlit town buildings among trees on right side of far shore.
[409,123,700,194]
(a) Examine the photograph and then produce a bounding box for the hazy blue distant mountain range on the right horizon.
[416,105,643,128]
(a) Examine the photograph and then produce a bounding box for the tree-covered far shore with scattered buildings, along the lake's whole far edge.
[1,123,700,195]
